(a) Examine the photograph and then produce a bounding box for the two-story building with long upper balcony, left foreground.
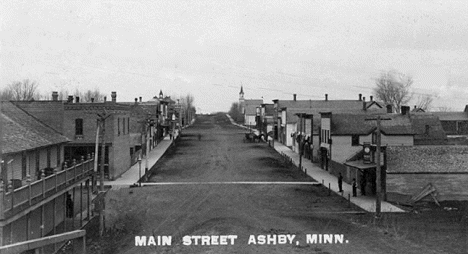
[0,102,94,246]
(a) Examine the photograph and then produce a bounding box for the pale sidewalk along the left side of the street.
[104,137,173,189]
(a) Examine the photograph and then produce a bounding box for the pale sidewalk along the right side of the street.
[274,142,405,213]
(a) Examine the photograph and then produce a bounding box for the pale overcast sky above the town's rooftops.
[0,0,468,113]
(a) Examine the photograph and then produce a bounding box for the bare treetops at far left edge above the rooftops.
[1,79,39,101]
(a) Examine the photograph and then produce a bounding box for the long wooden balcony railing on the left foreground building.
[0,159,94,216]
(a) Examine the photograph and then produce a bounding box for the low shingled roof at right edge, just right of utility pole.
[387,145,468,173]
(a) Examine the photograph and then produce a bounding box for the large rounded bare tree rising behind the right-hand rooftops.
[374,70,413,113]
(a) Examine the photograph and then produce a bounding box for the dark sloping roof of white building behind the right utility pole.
[331,114,414,135]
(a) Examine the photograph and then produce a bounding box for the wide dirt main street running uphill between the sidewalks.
[88,114,464,253]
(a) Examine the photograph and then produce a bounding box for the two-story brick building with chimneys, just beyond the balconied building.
[13,92,132,180]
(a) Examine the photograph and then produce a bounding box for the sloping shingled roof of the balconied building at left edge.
[0,102,70,154]
